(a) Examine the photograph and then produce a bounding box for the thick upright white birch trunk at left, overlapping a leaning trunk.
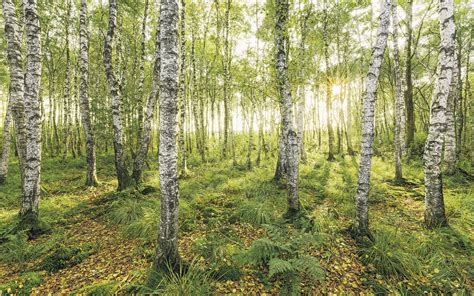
[20,0,41,217]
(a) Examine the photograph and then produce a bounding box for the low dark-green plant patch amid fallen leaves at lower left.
[37,244,97,273]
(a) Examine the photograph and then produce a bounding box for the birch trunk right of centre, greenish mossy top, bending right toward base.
[275,0,300,216]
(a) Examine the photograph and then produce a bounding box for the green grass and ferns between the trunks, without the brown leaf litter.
[0,147,474,295]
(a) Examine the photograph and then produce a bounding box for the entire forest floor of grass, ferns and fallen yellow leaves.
[0,151,474,295]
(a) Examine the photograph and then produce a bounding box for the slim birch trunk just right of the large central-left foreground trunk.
[179,0,187,177]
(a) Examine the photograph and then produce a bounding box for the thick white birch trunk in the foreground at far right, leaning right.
[423,0,456,228]
